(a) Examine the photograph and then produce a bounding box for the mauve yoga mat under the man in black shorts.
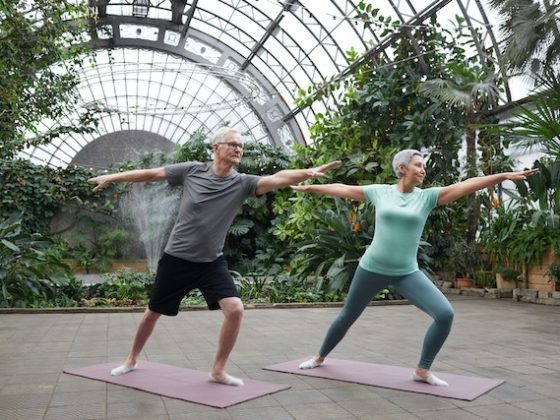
[64,361,290,408]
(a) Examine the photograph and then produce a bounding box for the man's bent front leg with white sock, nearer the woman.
[210,297,243,385]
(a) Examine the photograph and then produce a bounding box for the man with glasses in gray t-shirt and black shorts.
[89,127,340,386]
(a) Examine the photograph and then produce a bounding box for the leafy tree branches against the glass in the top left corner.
[0,0,95,158]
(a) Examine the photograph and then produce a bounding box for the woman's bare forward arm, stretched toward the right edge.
[438,169,539,205]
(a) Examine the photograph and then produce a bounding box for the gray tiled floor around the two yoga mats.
[0,296,560,420]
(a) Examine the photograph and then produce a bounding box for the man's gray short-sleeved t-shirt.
[165,162,261,262]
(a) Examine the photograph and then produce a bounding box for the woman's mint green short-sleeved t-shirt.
[360,184,439,276]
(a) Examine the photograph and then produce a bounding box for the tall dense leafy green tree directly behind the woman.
[274,11,490,278]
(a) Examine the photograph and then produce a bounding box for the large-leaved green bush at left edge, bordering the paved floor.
[0,214,70,307]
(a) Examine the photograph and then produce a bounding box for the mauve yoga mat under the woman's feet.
[263,357,505,401]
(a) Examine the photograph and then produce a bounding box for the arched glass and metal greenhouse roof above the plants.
[22,0,516,166]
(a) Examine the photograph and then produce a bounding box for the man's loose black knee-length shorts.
[148,253,239,316]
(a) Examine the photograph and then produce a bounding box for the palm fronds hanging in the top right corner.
[489,0,560,78]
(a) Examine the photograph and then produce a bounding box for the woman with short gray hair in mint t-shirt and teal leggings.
[292,149,537,386]
